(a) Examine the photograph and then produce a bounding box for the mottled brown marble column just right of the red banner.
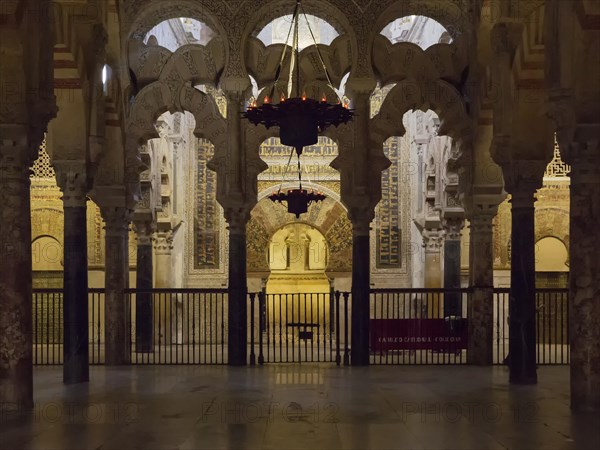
[467,211,498,366]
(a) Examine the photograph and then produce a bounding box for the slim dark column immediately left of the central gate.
[227,212,249,366]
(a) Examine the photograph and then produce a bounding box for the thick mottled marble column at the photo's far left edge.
[0,129,33,411]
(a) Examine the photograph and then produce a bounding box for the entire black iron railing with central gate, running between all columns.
[32,288,569,365]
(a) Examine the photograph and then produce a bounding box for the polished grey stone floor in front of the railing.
[0,364,600,450]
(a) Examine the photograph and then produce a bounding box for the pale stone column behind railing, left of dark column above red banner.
[423,228,443,319]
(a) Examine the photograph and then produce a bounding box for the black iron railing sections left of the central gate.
[32,289,227,365]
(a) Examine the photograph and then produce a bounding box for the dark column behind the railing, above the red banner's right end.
[444,217,464,317]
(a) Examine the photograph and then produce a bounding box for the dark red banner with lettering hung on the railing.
[371,319,468,352]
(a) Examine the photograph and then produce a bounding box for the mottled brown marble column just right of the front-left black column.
[102,207,131,366]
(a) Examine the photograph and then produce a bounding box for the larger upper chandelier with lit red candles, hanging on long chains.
[243,0,354,156]
